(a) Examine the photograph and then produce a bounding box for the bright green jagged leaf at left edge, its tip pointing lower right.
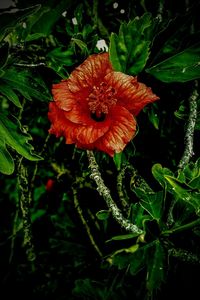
[0,114,42,173]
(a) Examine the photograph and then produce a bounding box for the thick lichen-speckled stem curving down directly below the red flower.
[87,150,143,234]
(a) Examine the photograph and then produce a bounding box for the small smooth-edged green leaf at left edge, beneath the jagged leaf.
[0,136,14,175]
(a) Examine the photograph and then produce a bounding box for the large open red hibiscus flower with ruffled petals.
[48,53,158,156]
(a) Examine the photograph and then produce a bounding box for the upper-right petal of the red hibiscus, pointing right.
[105,72,159,116]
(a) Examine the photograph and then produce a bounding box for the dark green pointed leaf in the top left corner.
[0,4,41,42]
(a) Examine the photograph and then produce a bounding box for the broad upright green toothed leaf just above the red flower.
[109,13,153,75]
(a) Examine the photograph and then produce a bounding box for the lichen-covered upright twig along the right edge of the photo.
[178,80,199,169]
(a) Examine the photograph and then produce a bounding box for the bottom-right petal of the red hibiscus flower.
[95,105,136,156]
